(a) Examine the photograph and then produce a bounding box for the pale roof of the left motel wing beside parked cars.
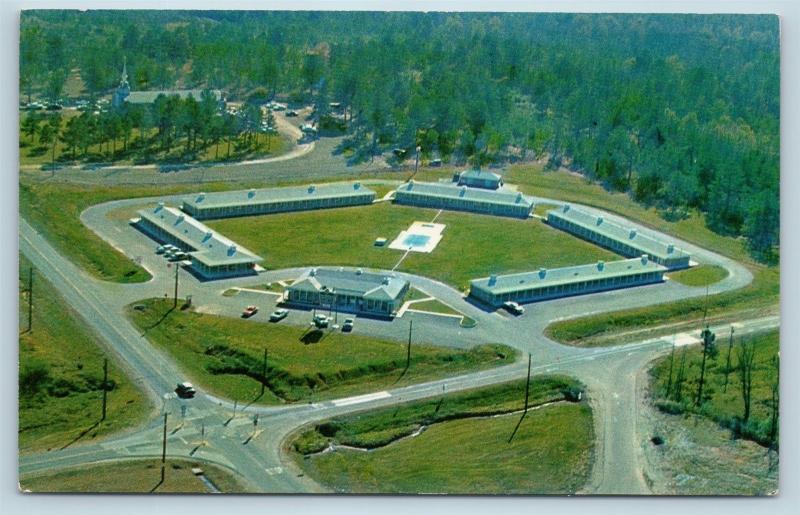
[138,203,262,266]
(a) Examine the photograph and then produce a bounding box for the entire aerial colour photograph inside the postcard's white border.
[17,10,788,496]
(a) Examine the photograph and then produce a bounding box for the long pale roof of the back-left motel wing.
[182,182,375,210]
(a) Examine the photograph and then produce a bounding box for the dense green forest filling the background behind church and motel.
[20,11,780,260]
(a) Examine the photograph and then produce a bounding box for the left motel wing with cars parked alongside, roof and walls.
[136,203,262,279]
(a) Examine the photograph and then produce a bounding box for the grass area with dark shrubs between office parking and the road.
[129,299,516,404]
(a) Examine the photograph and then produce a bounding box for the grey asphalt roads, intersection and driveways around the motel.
[19,177,779,494]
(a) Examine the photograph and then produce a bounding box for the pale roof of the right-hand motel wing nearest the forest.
[547,205,689,259]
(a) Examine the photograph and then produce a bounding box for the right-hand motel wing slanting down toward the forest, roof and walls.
[547,204,691,270]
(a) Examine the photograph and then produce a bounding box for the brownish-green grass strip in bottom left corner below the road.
[20,458,249,494]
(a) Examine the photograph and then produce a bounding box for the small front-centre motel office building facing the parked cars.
[284,268,409,317]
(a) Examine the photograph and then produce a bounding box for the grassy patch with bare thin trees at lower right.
[650,331,780,444]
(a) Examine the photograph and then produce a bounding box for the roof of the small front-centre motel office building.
[289,268,408,300]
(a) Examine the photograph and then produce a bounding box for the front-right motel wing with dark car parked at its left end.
[469,255,667,307]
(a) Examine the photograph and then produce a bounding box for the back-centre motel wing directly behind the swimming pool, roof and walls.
[394,181,533,218]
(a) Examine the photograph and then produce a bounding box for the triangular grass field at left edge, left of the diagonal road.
[19,256,152,452]
